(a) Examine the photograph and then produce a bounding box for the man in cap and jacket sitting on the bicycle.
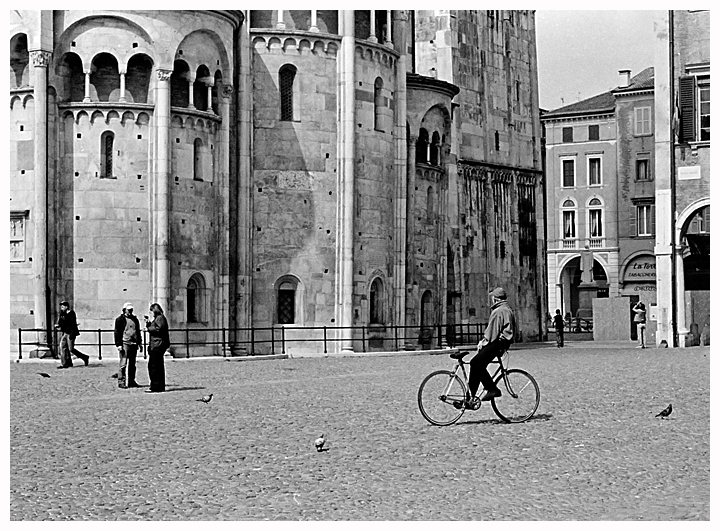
[465,288,515,409]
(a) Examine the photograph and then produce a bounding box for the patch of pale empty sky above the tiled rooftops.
[535,9,655,110]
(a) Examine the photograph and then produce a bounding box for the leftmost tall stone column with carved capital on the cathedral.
[30,50,52,357]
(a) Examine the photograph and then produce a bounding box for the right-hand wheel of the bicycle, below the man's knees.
[491,369,540,423]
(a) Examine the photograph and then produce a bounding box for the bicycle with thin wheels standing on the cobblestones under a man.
[418,350,540,426]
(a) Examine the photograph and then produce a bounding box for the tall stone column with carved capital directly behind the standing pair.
[153,68,172,315]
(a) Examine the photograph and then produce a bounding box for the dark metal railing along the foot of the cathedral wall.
[18,323,487,360]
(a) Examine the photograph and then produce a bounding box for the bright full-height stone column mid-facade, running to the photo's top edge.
[335,10,355,351]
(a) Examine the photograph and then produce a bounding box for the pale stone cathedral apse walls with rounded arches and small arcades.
[10,10,547,354]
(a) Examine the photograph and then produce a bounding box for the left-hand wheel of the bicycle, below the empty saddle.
[418,371,467,426]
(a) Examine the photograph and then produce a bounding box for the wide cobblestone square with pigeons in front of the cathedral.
[10,347,710,520]
